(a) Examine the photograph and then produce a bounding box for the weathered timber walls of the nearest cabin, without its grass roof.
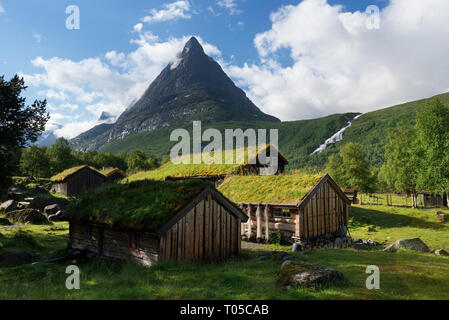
[69,182,247,266]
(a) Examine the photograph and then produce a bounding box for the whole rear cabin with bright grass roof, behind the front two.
[129,145,288,187]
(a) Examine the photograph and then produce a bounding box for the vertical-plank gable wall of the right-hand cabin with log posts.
[296,182,348,238]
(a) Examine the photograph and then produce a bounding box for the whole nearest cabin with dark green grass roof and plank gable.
[68,179,248,266]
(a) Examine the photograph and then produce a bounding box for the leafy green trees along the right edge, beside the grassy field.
[326,98,449,207]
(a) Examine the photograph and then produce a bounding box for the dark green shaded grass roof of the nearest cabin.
[67,179,208,231]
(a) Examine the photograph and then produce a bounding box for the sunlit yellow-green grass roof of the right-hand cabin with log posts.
[218,173,323,204]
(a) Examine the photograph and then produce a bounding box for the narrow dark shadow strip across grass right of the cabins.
[350,207,449,230]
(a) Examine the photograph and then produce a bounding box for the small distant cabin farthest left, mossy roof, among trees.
[51,165,106,196]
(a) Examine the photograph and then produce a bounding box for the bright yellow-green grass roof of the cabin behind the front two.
[128,146,280,182]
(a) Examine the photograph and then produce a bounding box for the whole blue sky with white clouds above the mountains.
[0,0,449,138]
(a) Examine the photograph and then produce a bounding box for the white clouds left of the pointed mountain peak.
[22,32,221,138]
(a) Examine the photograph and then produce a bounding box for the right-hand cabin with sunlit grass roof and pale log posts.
[219,174,350,242]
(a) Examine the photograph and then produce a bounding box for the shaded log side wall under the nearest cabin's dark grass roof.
[70,222,159,266]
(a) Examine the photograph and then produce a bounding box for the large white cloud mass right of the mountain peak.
[228,0,449,120]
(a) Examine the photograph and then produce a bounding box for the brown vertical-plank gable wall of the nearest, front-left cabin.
[160,198,241,262]
